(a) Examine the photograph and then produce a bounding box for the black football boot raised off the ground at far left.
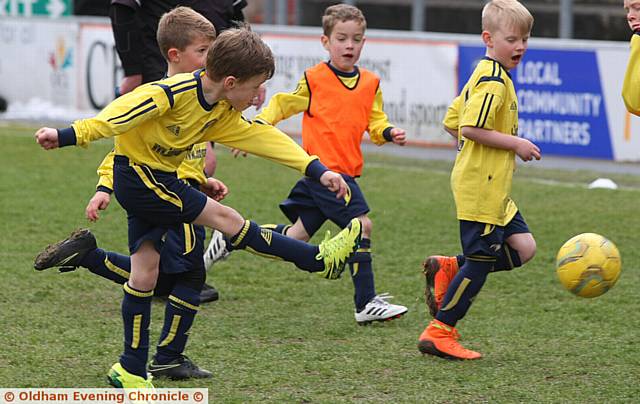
[33,229,97,272]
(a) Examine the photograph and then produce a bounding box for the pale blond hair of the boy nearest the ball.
[482,0,533,34]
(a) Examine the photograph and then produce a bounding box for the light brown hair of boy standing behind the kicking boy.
[156,6,216,60]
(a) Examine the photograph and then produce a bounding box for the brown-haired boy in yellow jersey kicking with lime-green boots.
[35,29,361,388]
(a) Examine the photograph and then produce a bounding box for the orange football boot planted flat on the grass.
[418,320,482,360]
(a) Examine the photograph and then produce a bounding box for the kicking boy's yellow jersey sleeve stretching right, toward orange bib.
[204,110,318,174]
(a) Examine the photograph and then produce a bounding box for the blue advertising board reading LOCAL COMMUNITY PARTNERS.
[458,46,613,160]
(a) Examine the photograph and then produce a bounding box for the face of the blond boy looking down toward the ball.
[482,26,529,70]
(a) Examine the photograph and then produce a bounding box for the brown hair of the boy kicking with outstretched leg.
[206,28,275,81]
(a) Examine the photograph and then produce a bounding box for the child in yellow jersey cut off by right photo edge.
[622,0,640,116]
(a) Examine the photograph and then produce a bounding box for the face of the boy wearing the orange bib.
[321,21,365,72]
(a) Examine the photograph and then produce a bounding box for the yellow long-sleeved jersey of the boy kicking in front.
[72,70,316,173]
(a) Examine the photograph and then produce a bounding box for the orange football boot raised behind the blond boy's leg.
[422,255,458,318]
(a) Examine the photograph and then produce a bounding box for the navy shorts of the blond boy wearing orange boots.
[460,211,531,257]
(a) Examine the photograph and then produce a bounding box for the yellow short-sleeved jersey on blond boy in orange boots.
[445,58,518,226]
